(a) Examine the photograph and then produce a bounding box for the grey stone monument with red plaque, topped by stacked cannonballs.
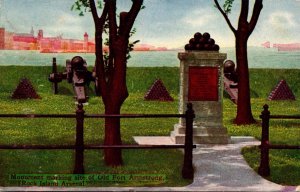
[171,33,229,144]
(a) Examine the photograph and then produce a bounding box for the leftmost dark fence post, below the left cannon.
[73,103,84,174]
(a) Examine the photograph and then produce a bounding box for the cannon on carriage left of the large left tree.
[48,56,96,103]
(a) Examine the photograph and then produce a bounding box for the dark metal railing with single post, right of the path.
[258,105,300,176]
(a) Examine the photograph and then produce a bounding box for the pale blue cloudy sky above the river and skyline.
[0,0,300,48]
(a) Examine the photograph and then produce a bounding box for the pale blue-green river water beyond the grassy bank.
[0,47,300,69]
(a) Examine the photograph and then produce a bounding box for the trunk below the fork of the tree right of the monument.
[234,31,256,125]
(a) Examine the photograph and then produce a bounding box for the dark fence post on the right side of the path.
[258,104,270,176]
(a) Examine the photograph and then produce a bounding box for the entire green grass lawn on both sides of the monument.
[0,66,300,186]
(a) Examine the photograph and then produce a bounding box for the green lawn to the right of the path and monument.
[224,69,300,185]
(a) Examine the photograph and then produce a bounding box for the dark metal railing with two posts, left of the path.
[0,103,196,179]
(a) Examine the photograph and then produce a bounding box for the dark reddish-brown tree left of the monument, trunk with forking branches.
[85,0,143,166]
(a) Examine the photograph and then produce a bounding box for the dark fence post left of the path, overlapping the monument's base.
[182,103,195,179]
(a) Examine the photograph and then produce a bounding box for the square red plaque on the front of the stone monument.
[188,67,218,101]
